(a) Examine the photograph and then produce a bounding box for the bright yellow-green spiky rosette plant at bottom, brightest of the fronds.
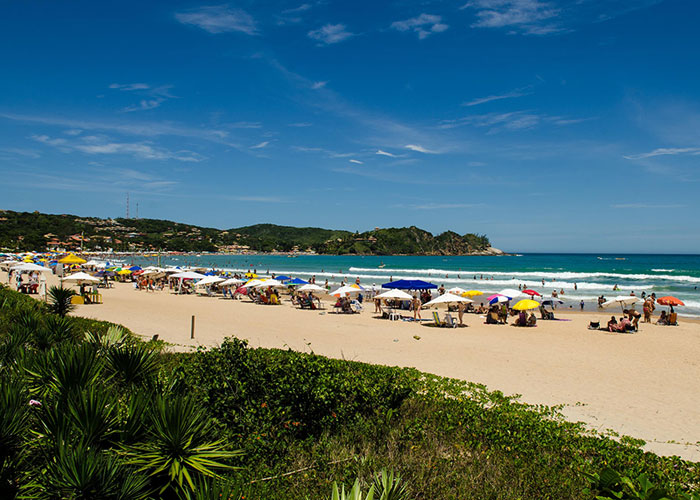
[121,396,242,494]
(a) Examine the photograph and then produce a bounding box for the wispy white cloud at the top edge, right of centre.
[462,0,562,35]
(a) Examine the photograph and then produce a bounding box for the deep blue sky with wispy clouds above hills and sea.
[0,0,700,253]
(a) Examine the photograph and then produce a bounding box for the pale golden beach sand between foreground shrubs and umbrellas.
[9,276,700,461]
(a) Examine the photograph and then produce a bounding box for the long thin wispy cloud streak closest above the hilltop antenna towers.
[30,135,205,162]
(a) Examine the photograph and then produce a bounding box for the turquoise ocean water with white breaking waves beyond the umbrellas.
[133,254,700,317]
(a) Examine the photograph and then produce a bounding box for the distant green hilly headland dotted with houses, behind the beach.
[0,210,490,255]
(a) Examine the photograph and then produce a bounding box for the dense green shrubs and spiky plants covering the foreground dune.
[0,289,700,500]
